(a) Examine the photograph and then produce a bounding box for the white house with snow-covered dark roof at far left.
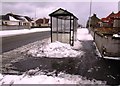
[0,13,33,29]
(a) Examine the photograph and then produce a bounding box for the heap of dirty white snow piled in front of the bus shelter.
[27,41,83,58]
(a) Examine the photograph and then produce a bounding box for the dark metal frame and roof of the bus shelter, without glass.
[49,8,78,46]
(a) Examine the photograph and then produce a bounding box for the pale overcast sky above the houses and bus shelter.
[2,2,118,25]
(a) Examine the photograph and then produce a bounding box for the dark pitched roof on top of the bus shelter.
[49,8,78,19]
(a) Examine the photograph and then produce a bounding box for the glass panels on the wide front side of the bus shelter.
[52,17,70,43]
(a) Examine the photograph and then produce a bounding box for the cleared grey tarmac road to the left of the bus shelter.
[2,31,50,53]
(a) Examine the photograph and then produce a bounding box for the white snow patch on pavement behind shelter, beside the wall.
[77,28,93,41]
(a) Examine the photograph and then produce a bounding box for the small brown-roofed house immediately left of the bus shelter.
[35,18,49,27]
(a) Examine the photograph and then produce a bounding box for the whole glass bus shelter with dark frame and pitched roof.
[49,8,78,46]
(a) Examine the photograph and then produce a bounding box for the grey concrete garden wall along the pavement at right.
[91,31,120,56]
